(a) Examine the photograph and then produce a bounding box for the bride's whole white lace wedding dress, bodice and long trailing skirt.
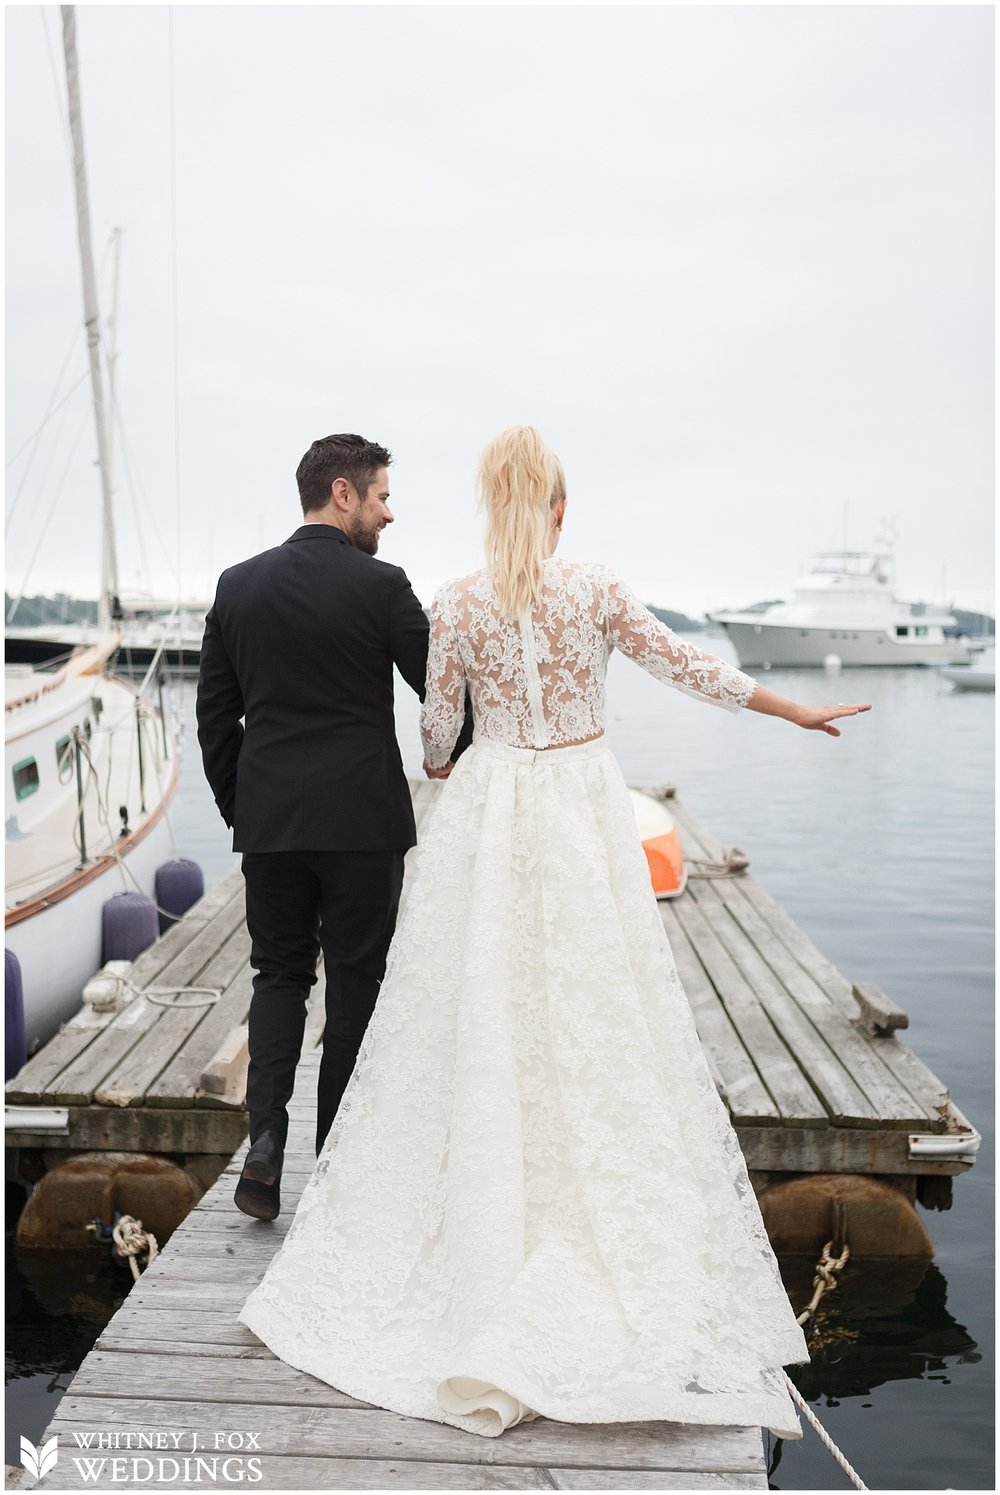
[239,558,809,1438]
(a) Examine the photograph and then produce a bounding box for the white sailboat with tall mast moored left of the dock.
[4,6,181,1069]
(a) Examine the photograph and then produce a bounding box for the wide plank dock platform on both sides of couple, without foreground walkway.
[6,782,976,1202]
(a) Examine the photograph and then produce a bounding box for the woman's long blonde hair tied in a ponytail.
[480,426,567,617]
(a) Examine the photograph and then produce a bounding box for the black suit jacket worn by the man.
[197,525,471,852]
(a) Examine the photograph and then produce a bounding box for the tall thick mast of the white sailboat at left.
[60,4,117,632]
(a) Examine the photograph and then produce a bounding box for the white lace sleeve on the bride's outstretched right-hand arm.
[607,573,756,712]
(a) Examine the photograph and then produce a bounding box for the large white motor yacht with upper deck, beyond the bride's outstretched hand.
[709,550,970,670]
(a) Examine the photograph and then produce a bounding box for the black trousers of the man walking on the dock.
[244,851,404,1154]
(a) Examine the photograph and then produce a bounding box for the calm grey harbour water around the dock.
[6,638,994,1491]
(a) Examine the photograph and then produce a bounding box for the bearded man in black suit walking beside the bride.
[197,435,471,1220]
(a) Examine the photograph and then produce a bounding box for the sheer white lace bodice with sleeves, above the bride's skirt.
[420,556,756,768]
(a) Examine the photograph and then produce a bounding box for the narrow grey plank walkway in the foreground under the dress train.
[24,1052,767,1491]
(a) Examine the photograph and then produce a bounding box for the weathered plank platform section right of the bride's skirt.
[659,797,978,1180]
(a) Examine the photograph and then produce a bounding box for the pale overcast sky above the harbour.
[4,4,994,614]
